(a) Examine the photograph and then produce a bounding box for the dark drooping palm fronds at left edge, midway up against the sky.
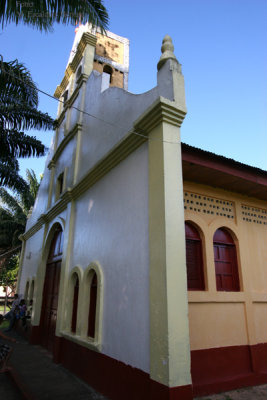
[0,60,54,191]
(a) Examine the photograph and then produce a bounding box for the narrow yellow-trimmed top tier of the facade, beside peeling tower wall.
[54,32,97,99]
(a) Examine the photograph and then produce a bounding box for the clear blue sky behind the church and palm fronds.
[0,0,267,179]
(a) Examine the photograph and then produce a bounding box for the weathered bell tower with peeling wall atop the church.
[55,24,129,104]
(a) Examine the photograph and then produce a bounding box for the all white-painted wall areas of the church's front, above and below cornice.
[20,32,184,372]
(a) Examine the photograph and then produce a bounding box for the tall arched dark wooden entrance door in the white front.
[41,230,62,351]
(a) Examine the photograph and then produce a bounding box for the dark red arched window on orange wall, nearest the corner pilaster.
[185,222,205,290]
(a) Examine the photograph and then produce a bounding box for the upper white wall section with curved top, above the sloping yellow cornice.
[78,71,158,180]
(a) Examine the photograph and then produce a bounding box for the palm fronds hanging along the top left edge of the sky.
[0,0,108,31]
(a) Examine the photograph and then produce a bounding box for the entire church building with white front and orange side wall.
[18,26,267,400]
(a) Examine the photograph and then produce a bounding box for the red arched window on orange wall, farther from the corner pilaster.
[213,228,240,292]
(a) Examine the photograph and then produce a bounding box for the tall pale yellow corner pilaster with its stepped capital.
[136,98,191,387]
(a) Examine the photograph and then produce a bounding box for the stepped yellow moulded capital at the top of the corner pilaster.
[134,97,186,134]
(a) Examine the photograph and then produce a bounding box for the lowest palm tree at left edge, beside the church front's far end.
[0,169,40,285]
